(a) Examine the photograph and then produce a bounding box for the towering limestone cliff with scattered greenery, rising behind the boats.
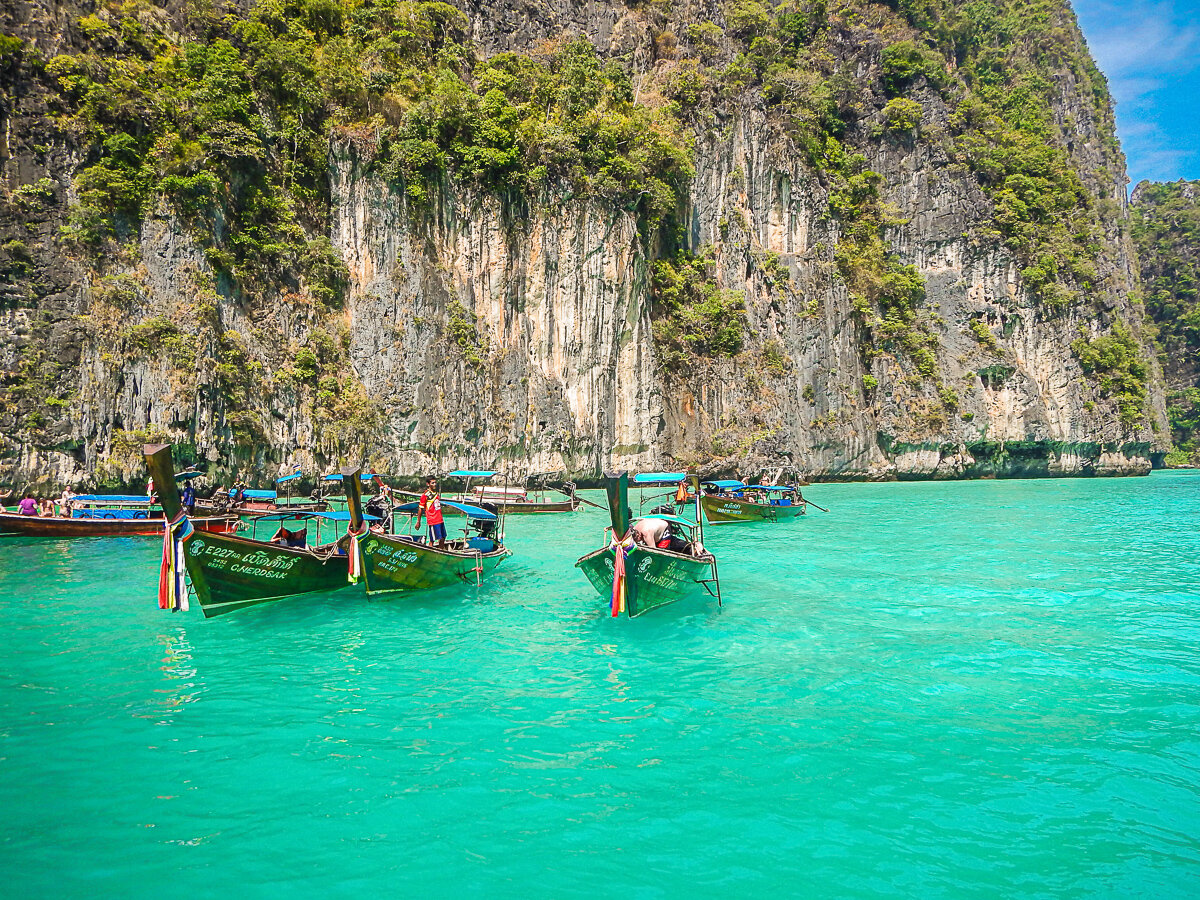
[0,0,1165,494]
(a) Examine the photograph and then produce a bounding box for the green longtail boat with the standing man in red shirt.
[359,500,510,594]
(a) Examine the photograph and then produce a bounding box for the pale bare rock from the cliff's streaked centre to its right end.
[312,114,1151,478]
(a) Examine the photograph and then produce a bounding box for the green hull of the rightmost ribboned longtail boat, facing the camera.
[575,546,715,617]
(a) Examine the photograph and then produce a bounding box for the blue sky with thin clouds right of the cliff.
[1073,0,1200,186]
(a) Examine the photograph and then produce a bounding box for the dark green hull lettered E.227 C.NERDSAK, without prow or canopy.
[184,534,350,618]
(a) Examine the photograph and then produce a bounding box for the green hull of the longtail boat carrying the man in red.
[359,534,509,594]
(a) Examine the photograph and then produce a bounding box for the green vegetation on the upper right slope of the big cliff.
[668,0,1123,310]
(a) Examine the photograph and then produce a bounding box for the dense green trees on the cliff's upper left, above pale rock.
[46,0,691,283]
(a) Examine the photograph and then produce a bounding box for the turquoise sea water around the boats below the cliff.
[0,473,1200,898]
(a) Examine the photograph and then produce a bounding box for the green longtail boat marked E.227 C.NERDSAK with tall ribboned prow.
[145,444,366,617]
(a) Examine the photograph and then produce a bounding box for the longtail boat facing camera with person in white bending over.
[575,472,721,617]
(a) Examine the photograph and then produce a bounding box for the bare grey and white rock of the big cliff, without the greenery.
[0,2,1165,494]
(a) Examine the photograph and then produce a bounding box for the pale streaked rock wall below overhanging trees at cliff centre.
[332,141,662,474]
